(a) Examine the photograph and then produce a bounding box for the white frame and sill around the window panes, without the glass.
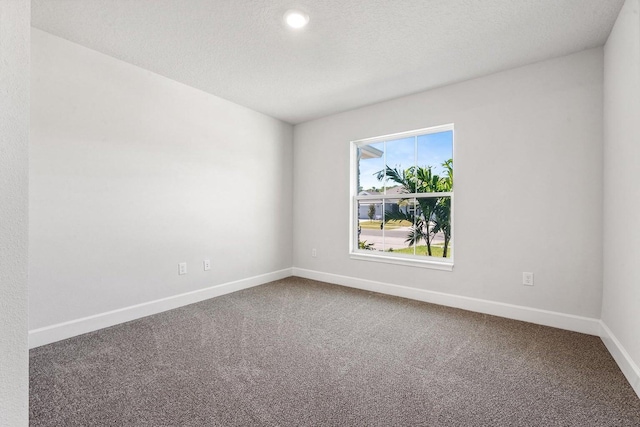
[349,123,455,271]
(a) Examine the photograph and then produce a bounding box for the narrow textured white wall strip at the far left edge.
[0,0,31,426]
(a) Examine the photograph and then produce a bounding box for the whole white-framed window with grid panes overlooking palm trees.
[351,125,453,270]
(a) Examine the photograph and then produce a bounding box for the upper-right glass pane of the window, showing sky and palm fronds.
[412,131,453,193]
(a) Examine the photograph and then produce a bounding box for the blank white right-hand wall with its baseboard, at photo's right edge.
[602,0,640,395]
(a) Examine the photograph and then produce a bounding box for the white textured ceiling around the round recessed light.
[31,0,624,123]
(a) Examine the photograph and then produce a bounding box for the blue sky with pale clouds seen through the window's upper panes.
[360,131,453,189]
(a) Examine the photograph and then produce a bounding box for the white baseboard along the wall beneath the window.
[293,267,601,336]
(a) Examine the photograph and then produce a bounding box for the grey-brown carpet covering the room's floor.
[30,278,640,427]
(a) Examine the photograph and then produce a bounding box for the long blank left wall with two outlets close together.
[29,29,292,338]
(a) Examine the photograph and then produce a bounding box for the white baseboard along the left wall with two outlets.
[29,268,291,348]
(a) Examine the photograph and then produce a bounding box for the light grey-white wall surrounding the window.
[294,48,603,320]
